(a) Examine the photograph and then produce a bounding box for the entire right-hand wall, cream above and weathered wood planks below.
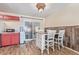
[45,4,79,51]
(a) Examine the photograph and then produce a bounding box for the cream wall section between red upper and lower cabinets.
[0,20,20,33]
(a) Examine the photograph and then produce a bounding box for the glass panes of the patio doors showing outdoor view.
[24,21,40,41]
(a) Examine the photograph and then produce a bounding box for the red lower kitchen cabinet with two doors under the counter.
[1,33,20,46]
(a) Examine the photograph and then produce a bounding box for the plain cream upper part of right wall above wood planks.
[45,4,79,27]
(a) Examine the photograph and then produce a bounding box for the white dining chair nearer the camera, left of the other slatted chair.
[46,30,56,54]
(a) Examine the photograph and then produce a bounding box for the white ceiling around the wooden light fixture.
[0,3,68,18]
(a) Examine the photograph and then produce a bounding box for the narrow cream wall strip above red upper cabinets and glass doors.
[0,12,45,29]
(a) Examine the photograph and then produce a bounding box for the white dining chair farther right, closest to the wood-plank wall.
[55,30,65,49]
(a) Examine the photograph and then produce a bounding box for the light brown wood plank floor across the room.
[0,41,77,55]
